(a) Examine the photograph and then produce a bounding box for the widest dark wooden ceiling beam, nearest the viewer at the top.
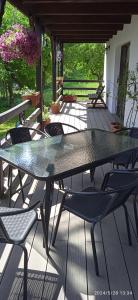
[24,1,138,16]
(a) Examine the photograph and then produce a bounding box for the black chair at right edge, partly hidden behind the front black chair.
[101,168,138,236]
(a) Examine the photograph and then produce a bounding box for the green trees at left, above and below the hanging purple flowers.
[0,3,35,106]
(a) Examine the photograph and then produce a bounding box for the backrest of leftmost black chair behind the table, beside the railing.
[6,127,46,145]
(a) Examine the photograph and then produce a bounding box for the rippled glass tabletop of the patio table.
[0,129,138,180]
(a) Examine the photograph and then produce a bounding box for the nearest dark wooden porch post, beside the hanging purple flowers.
[35,22,43,122]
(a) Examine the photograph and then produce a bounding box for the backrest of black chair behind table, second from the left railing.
[44,122,78,136]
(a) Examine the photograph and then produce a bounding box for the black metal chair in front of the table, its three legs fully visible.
[52,172,138,276]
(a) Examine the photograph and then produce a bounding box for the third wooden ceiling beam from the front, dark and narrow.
[48,23,123,32]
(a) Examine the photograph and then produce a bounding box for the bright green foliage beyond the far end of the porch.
[64,43,105,80]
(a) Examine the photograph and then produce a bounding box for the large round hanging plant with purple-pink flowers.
[0,24,40,65]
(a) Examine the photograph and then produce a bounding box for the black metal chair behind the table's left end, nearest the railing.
[6,127,46,204]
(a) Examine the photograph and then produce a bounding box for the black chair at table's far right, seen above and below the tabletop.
[112,127,138,168]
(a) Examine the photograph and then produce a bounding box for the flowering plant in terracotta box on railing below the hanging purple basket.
[21,89,40,107]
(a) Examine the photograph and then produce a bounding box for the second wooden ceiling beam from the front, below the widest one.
[41,15,131,25]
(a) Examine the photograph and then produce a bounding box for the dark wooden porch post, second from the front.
[51,37,56,101]
